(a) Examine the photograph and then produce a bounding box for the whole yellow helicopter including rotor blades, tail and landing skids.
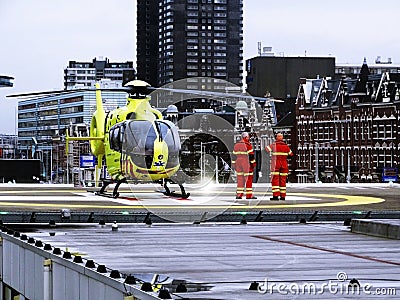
[7,79,282,199]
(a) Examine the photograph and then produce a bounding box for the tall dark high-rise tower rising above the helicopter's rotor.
[137,0,243,86]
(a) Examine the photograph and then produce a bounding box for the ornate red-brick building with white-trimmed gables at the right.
[292,63,400,182]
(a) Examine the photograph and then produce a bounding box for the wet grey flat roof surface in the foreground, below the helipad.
[28,222,400,299]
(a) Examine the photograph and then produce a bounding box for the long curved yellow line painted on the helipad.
[0,193,385,209]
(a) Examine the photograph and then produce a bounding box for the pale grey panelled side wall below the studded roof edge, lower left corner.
[0,233,157,300]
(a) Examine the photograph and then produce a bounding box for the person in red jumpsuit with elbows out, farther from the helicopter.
[265,133,293,200]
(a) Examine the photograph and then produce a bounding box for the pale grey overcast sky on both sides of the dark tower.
[0,0,400,134]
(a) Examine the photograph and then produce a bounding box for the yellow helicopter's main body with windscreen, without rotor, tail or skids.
[104,97,180,181]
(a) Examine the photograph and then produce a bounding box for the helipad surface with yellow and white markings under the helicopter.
[0,184,390,211]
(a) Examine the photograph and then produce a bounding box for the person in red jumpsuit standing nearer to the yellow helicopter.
[232,132,257,199]
